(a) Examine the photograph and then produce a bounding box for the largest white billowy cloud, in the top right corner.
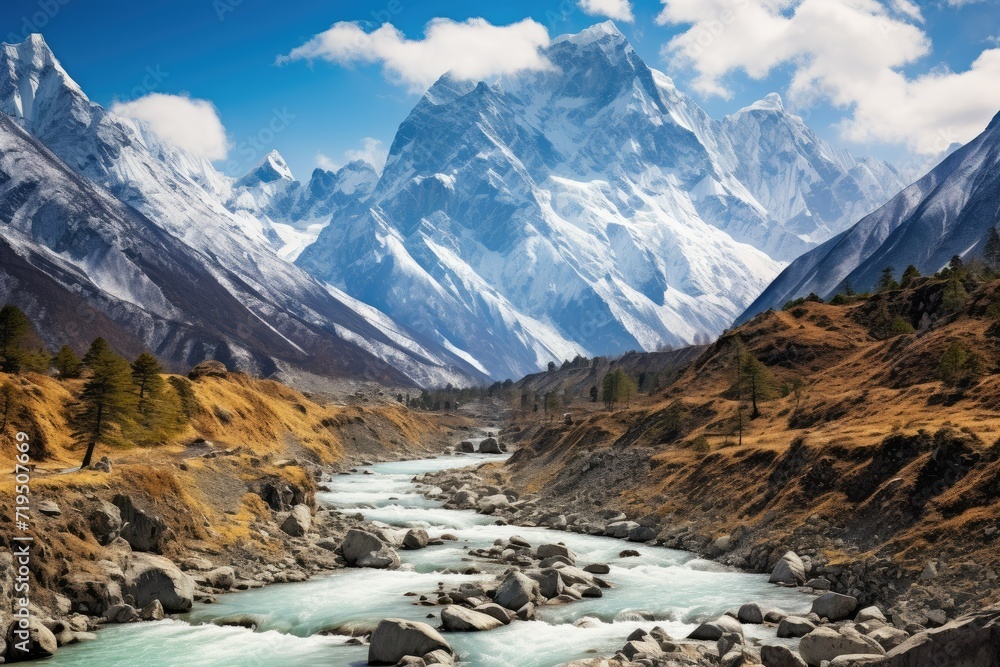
[657,0,1000,154]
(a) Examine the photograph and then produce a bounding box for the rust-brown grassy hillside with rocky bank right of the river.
[504,279,1000,608]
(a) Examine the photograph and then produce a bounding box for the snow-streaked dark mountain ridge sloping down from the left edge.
[0,35,483,385]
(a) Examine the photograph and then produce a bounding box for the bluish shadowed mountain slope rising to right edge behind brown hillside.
[738,109,1000,322]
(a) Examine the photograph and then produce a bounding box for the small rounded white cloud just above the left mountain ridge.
[111,93,229,160]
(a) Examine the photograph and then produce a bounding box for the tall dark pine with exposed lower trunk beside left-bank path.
[75,348,136,468]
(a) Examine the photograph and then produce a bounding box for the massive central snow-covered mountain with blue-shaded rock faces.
[297,22,903,377]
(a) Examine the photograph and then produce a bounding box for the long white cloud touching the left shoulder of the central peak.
[277,18,551,92]
